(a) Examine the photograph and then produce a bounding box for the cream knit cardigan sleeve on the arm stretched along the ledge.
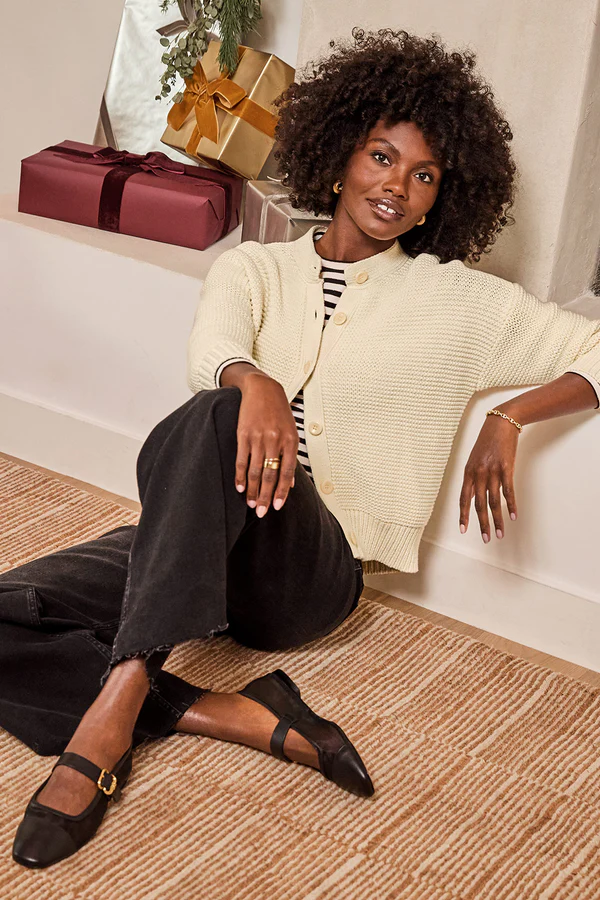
[477,284,600,406]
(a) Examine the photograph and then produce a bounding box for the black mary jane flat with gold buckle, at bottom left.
[13,747,133,869]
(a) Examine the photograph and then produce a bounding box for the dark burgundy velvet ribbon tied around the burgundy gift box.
[45,145,232,240]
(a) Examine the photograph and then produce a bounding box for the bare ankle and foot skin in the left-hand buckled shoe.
[37,658,149,816]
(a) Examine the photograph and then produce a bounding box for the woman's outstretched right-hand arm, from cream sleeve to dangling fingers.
[459,285,600,543]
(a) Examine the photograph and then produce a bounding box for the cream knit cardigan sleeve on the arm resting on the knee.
[187,247,263,394]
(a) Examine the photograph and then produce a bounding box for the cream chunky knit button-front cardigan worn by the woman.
[187,225,600,574]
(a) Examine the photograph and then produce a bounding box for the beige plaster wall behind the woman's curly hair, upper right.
[297,0,600,306]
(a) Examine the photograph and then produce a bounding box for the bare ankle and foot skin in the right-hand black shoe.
[175,691,319,769]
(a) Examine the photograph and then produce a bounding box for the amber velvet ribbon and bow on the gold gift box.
[167,47,277,156]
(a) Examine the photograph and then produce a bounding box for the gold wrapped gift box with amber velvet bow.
[161,41,295,178]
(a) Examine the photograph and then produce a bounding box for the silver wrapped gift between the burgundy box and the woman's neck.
[242,180,331,244]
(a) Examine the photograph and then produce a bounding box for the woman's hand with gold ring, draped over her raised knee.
[235,371,299,517]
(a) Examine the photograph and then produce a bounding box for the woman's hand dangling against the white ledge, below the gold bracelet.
[459,416,519,544]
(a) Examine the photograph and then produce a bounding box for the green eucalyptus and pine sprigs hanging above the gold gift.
[155,0,262,103]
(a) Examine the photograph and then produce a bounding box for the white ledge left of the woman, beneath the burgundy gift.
[0,195,241,444]
